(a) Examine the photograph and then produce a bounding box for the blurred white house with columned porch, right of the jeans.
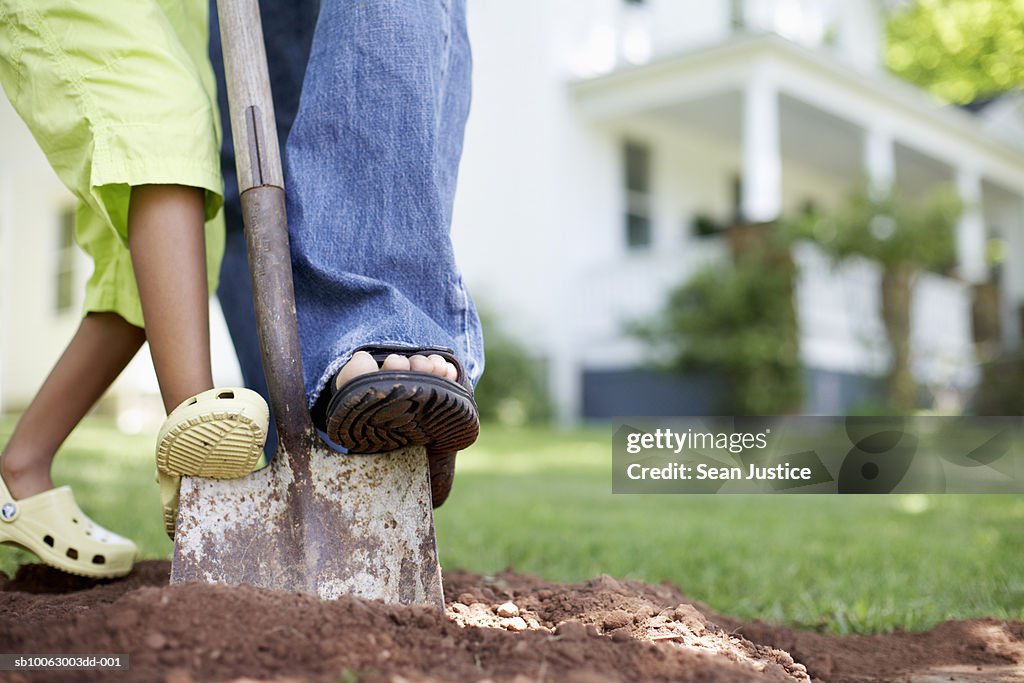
[454,0,1024,420]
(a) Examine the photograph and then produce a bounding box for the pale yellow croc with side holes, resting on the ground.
[0,477,138,579]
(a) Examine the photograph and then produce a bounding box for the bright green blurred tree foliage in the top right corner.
[886,0,1024,103]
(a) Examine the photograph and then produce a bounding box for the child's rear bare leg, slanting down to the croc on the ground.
[0,313,145,499]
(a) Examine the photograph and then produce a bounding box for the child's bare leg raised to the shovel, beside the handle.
[128,185,213,413]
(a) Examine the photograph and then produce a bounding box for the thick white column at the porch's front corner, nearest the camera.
[740,70,782,223]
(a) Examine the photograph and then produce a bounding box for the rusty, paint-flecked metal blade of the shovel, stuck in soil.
[171,435,443,608]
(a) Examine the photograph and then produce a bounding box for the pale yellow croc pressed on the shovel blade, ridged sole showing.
[157,388,269,539]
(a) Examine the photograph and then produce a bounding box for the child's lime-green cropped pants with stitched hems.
[0,0,224,327]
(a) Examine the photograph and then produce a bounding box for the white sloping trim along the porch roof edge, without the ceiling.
[569,33,1024,188]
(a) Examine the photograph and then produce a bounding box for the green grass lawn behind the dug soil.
[0,419,1024,633]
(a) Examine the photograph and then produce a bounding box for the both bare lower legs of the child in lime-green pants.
[0,185,213,499]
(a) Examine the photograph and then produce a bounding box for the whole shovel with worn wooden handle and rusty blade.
[171,0,444,609]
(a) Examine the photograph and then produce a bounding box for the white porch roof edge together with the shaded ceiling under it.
[569,35,1024,192]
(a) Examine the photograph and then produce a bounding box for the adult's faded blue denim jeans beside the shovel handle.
[211,0,483,444]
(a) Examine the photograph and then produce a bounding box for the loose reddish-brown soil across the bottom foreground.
[0,561,1024,683]
